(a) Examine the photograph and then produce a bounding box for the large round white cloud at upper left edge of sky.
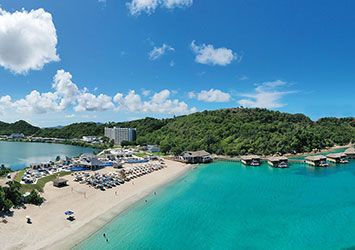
[0,8,60,74]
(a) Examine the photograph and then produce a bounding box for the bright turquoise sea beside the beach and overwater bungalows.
[74,153,355,249]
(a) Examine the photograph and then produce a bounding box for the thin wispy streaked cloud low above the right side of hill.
[238,80,295,108]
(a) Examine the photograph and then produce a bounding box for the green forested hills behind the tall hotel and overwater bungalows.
[2,108,355,155]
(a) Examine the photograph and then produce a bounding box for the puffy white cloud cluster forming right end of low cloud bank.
[113,89,196,114]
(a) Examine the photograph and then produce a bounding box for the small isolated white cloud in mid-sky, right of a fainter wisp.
[191,41,241,66]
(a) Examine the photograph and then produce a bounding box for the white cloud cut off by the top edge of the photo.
[126,0,193,15]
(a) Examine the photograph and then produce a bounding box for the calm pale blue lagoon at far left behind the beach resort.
[0,141,94,170]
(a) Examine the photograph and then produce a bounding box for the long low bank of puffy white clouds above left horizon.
[0,70,196,118]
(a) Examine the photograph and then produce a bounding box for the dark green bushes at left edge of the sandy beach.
[0,181,43,213]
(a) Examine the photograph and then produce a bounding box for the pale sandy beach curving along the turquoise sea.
[0,160,190,249]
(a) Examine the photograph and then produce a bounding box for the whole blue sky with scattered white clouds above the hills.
[0,0,355,127]
